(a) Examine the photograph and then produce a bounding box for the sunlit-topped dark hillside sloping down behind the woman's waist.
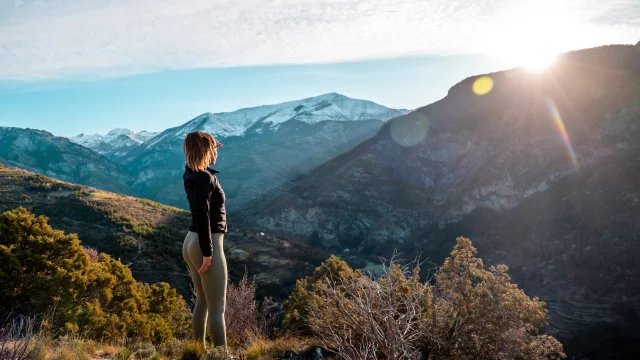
[0,166,327,299]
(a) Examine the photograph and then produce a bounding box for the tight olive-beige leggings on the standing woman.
[182,231,227,349]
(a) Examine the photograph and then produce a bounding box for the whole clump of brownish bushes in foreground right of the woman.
[285,238,565,359]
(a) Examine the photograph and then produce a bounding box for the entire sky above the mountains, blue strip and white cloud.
[0,0,640,136]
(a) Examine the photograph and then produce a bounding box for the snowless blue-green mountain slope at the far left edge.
[0,127,132,194]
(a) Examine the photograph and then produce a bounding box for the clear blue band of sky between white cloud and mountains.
[0,55,498,136]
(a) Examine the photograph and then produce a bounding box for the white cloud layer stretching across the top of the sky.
[0,0,640,80]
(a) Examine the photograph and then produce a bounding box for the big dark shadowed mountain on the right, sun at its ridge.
[235,45,640,352]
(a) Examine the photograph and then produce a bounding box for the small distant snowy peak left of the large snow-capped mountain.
[69,128,158,159]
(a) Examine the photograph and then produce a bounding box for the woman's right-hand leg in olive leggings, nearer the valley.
[200,233,227,349]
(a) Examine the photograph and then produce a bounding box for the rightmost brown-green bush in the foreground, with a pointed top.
[431,238,564,359]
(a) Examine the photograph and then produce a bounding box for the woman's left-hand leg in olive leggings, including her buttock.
[182,231,207,345]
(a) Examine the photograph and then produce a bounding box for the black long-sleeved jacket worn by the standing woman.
[182,167,227,256]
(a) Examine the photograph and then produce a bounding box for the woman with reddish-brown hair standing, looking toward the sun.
[182,131,227,350]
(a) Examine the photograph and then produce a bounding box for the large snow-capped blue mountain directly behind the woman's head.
[121,93,406,208]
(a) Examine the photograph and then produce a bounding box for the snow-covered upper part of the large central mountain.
[145,93,408,148]
